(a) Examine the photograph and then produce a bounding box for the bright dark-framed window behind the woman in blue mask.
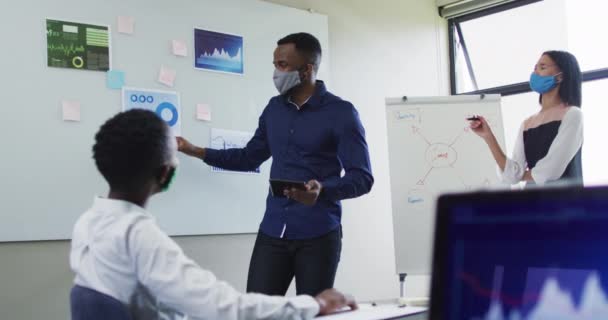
[448,0,608,184]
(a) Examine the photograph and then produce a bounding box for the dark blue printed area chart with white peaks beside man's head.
[194,29,243,74]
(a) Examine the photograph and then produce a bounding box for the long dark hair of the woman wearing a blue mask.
[539,50,583,108]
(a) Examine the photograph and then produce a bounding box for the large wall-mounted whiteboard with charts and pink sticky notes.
[0,0,329,241]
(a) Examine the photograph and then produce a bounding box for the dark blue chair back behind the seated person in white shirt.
[70,285,132,320]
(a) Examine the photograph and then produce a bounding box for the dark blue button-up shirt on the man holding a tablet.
[205,81,374,239]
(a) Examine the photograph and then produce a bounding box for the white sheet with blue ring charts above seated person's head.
[122,88,182,136]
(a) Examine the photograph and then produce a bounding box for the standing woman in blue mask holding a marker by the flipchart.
[470,51,583,185]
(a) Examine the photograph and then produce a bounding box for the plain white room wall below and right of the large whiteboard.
[0,0,449,319]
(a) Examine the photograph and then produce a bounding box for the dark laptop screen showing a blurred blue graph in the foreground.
[430,187,608,320]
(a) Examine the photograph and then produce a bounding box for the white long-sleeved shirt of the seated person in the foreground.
[70,198,319,319]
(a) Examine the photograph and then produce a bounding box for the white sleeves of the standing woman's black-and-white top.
[499,107,583,185]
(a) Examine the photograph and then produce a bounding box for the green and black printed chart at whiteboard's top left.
[46,19,110,71]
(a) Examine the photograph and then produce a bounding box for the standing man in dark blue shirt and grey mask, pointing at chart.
[178,33,374,295]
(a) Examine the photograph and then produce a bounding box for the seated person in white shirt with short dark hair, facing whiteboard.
[70,110,356,319]
